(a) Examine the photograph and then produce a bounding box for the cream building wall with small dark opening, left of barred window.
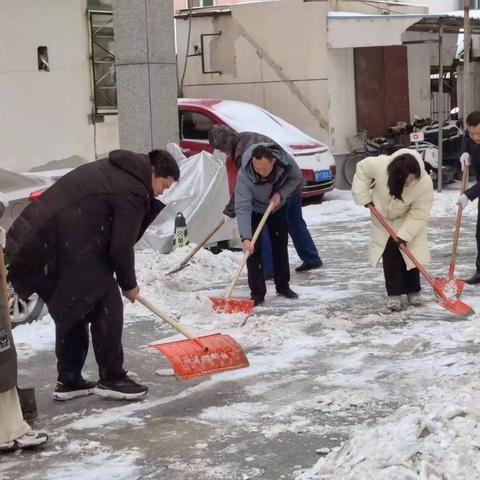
[0,0,118,171]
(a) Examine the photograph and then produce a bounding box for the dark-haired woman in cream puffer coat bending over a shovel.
[352,148,433,311]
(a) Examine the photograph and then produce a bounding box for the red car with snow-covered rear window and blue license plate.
[178,98,336,199]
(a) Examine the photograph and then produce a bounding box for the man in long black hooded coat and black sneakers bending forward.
[6,150,180,400]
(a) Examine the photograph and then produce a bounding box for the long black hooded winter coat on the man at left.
[6,150,164,321]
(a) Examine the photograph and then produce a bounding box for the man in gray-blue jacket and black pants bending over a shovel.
[235,143,303,305]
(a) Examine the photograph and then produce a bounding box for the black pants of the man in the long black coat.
[54,283,126,384]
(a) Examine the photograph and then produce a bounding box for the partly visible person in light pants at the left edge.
[0,227,48,453]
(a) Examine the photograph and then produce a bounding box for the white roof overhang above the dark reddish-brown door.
[327,10,480,48]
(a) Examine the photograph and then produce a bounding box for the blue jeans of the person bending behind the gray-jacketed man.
[262,194,321,278]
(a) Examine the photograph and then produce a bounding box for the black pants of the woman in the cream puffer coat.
[382,238,421,296]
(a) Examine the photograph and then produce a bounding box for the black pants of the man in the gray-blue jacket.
[247,206,290,299]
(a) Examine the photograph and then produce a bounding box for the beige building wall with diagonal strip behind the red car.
[176,0,329,143]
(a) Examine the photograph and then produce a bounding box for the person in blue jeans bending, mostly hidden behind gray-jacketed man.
[208,125,323,278]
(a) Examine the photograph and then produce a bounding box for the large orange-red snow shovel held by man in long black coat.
[137,295,249,380]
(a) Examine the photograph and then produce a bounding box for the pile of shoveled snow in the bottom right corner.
[297,379,480,480]
